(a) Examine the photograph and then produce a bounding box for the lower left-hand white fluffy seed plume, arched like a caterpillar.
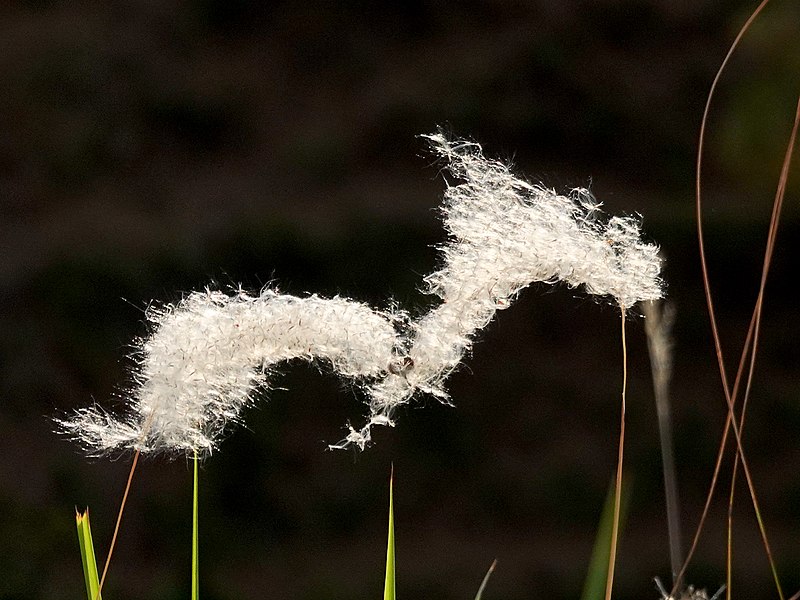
[61,290,404,453]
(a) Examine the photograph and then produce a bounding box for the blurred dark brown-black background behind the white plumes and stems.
[0,0,800,600]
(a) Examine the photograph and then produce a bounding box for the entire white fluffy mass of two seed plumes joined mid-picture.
[60,133,663,453]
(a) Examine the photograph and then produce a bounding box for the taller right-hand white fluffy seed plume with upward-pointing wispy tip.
[345,133,664,447]
